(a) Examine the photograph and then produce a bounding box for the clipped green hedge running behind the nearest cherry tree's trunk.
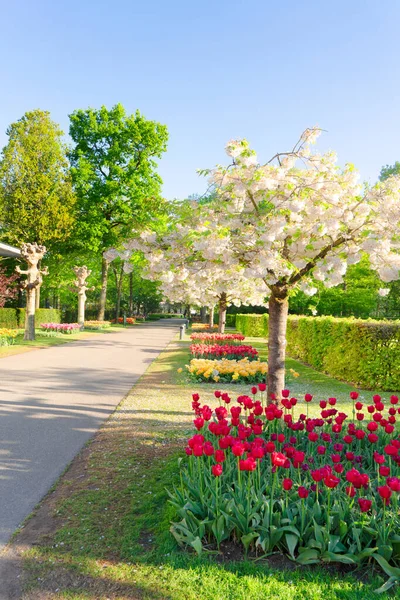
[236,315,400,392]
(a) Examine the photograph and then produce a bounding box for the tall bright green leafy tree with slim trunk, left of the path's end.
[70,104,168,319]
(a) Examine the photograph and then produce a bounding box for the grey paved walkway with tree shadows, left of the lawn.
[0,320,181,549]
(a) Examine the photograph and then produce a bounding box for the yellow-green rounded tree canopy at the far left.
[0,110,75,251]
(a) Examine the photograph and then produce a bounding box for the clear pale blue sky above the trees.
[0,0,400,198]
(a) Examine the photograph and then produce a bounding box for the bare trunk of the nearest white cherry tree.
[268,288,289,400]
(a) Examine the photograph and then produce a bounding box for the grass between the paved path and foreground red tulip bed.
[20,332,393,600]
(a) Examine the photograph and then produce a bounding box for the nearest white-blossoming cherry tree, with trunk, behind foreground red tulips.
[193,128,400,398]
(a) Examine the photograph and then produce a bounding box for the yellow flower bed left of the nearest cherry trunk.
[186,358,268,383]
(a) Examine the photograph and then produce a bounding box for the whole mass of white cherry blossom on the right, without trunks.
[127,127,400,306]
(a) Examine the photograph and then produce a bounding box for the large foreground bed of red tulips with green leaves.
[170,384,400,591]
